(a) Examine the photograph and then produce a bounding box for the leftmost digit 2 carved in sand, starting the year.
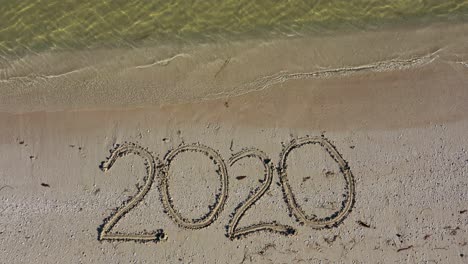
[98,142,167,242]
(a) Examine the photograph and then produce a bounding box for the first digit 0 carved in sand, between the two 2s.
[159,144,228,229]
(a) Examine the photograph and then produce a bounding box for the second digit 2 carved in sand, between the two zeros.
[227,148,295,240]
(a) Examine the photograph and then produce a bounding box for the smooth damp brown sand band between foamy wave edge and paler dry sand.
[0,54,468,134]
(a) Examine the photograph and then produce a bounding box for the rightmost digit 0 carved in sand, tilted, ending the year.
[278,137,355,229]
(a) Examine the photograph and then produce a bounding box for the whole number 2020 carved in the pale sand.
[98,137,355,242]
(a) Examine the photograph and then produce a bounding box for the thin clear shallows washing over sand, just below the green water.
[0,21,468,113]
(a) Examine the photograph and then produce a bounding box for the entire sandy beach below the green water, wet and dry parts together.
[0,24,468,263]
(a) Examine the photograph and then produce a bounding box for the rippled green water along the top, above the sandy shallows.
[0,0,468,55]
